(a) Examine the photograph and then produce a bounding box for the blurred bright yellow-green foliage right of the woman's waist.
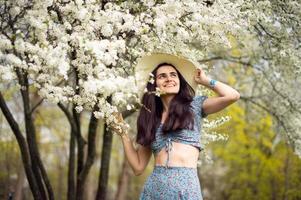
[205,105,301,200]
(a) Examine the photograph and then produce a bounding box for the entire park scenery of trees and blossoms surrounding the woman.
[0,0,301,200]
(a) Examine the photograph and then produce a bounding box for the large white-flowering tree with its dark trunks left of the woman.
[0,0,300,199]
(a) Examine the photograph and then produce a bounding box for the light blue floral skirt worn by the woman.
[139,166,203,200]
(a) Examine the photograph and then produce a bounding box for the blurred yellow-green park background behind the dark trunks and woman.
[0,64,301,200]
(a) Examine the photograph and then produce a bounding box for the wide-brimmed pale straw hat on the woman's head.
[135,53,197,93]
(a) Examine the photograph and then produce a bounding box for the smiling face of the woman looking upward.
[155,65,180,94]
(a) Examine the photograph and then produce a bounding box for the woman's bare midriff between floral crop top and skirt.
[155,142,199,168]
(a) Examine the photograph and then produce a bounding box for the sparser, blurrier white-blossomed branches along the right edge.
[213,0,301,157]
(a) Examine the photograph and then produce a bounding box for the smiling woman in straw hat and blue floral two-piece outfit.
[112,54,240,200]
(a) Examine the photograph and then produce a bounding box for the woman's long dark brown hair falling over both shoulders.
[136,63,195,146]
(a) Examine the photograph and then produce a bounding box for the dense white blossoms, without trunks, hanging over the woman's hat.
[0,0,262,159]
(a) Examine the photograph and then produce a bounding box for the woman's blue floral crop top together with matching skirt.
[139,96,207,200]
